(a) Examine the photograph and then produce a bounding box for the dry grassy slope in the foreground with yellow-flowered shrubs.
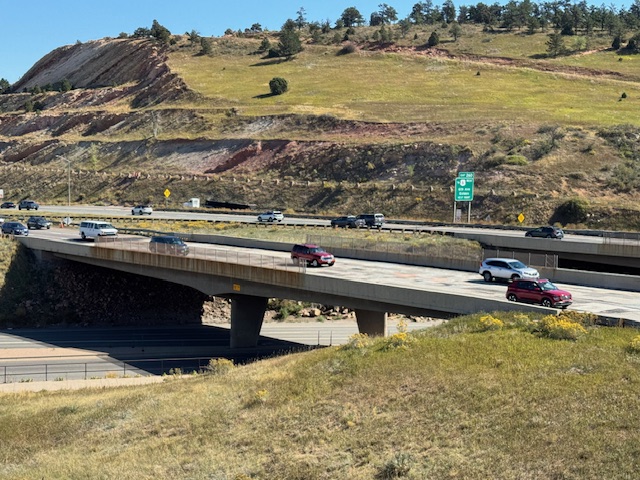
[0,314,640,480]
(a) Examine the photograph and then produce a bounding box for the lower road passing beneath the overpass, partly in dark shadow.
[0,320,432,384]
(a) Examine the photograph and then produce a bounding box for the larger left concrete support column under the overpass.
[230,295,269,348]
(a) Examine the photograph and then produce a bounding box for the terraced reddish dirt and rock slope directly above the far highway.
[0,39,638,227]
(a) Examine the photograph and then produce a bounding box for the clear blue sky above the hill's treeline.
[0,0,631,83]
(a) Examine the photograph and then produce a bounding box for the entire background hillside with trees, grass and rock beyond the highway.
[0,0,640,230]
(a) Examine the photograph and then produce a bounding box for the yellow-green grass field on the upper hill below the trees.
[170,28,640,125]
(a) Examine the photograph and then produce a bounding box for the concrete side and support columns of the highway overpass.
[19,236,557,348]
